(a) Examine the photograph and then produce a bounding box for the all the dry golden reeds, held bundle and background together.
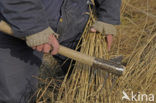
[35,0,156,103]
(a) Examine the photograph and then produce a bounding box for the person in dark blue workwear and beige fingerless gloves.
[0,0,121,103]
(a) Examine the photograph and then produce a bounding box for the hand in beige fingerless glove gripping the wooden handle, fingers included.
[26,27,59,55]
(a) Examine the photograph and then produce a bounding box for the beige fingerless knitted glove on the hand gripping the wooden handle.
[26,27,58,47]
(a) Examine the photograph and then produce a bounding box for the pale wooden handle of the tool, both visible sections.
[0,21,94,65]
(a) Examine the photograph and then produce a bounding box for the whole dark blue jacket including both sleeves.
[0,0,121,41]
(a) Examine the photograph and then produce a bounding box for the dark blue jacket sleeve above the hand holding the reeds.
[95,0,121,25]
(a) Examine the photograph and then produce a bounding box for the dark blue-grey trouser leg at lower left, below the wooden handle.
[0,33,42,103]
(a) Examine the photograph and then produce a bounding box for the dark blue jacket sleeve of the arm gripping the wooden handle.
[0,0,49,38]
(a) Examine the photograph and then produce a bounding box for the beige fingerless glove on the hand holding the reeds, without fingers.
[92,21,116,35]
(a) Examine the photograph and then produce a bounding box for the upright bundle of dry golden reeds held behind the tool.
[54,1,122,103]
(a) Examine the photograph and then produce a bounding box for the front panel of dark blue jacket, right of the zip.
[57,0,89,43]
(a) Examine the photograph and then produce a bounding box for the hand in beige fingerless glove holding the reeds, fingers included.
[91,21,116,51]
